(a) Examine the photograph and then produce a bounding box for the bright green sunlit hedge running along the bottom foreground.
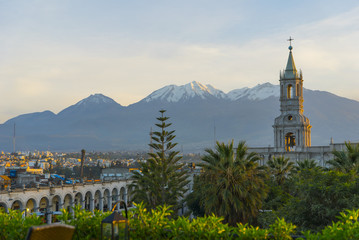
[0,204,359,240]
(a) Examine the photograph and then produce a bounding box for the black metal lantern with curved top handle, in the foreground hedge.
[101,200,130,240]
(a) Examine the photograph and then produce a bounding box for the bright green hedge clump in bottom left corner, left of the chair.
[0,208,43,240]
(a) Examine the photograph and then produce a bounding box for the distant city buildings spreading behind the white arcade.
[0,151,200,190]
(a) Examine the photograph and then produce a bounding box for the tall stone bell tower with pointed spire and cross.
[273,38,312,152]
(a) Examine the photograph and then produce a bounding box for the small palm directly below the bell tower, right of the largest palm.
[267,156,294,185]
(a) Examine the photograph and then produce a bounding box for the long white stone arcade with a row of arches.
[0,180,131,221]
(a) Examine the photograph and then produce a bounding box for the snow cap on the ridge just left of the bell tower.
[227,82,279,101]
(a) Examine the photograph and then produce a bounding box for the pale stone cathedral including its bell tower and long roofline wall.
[248,41,352,166]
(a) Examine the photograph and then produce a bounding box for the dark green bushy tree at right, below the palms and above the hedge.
[278,169,359,230]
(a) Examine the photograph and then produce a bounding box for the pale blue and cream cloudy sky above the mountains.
[0,0,359,122]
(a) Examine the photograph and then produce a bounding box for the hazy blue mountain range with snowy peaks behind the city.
[0,82,359,152]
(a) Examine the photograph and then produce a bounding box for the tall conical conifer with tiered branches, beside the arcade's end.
[131,110,189,209]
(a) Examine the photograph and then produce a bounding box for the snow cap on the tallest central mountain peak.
[144,81,226,102]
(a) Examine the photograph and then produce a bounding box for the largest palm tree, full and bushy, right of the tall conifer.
[198,140,267,225]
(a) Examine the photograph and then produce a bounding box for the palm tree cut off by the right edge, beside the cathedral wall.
[327,142,359,173]
